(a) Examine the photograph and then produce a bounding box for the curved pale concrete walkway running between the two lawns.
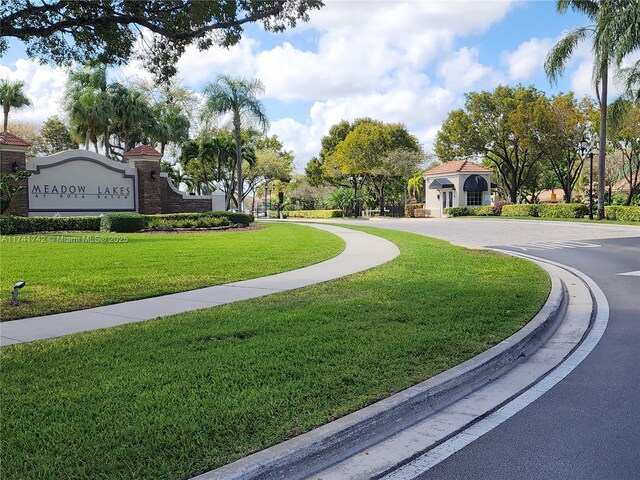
[0,223,400,346]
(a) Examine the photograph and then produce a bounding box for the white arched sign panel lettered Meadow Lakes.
[27,150,137,214]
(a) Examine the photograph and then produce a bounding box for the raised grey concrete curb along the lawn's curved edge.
[192,274,568,480]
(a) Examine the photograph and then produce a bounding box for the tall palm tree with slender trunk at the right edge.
[544,0,626,220]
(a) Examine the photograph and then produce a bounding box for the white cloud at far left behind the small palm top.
[0,59,67,123]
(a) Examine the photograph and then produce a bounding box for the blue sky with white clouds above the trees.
[0,0,633,170]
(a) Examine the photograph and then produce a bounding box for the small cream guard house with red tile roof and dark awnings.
[423,160,493,217]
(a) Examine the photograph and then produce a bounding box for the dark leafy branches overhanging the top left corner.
[0,0,323,79]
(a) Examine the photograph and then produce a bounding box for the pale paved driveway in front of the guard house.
[343,218,640,248]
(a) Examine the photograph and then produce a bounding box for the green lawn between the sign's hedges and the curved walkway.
[0,224,344,320]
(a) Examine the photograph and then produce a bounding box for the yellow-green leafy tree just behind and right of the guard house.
[435,85,544,203]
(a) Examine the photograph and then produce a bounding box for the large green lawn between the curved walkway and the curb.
[0,228,550,480]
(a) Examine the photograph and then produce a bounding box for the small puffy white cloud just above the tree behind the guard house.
[438,47,504,92]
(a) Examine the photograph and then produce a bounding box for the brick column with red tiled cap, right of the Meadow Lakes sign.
[125,145,164,215]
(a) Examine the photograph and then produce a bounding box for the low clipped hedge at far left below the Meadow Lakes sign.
[0,215,101,235]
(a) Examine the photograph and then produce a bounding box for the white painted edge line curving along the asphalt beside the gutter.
[383,253,608,480]
